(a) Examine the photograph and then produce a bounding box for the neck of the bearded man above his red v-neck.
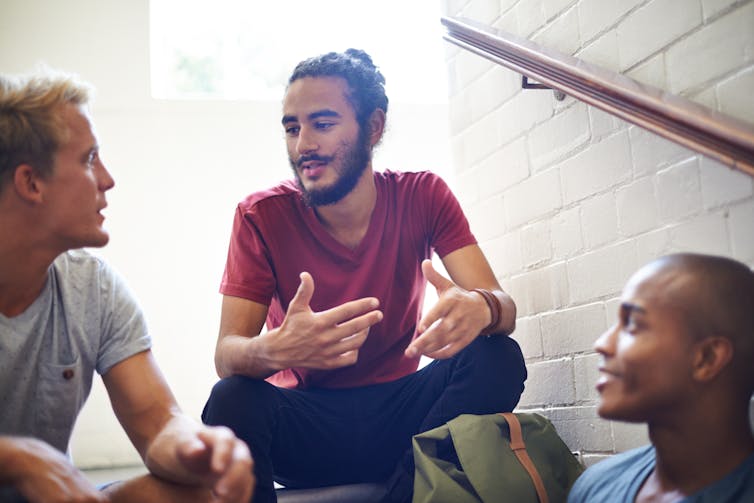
[314,163,377,248]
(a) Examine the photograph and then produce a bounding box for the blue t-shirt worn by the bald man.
[568,445,754,503]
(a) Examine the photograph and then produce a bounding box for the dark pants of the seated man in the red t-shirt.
[202,335,526,503]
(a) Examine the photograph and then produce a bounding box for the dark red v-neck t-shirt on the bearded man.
[220,171,476,388]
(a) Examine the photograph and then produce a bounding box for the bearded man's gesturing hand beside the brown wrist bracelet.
[406,260,491,359]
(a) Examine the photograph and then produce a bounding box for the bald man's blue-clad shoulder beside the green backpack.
[568,445,655,503]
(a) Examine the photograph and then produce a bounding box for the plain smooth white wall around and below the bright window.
[0,0,450,467]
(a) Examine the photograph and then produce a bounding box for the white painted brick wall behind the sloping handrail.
[443,0,754,462]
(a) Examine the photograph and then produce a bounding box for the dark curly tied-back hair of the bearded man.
[288,49,388,128]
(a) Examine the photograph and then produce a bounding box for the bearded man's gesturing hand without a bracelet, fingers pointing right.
[270,272,382,369]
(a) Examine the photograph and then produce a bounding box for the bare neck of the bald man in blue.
[649,400,754,495]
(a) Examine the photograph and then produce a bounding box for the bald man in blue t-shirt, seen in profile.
[568,254,754,503]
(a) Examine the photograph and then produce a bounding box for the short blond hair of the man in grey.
[0,69,92,191]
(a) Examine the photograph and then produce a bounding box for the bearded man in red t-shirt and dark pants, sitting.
[204,49,526,503]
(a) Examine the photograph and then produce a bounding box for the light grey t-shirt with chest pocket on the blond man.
[0,250,151,452]
